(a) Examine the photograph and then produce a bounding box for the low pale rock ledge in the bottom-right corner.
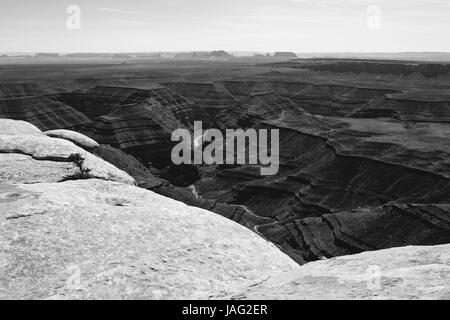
[232,244,450,300]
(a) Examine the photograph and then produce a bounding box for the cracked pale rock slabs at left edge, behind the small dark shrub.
[0,124,136,185]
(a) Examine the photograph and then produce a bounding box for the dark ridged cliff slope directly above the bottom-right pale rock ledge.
[257,204,450,263]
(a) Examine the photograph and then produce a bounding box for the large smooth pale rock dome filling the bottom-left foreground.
[0,179,298,299]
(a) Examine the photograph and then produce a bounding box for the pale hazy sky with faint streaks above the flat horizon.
[0,0,450,52]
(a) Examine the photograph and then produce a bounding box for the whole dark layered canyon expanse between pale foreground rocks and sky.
[0,58,450,264]
